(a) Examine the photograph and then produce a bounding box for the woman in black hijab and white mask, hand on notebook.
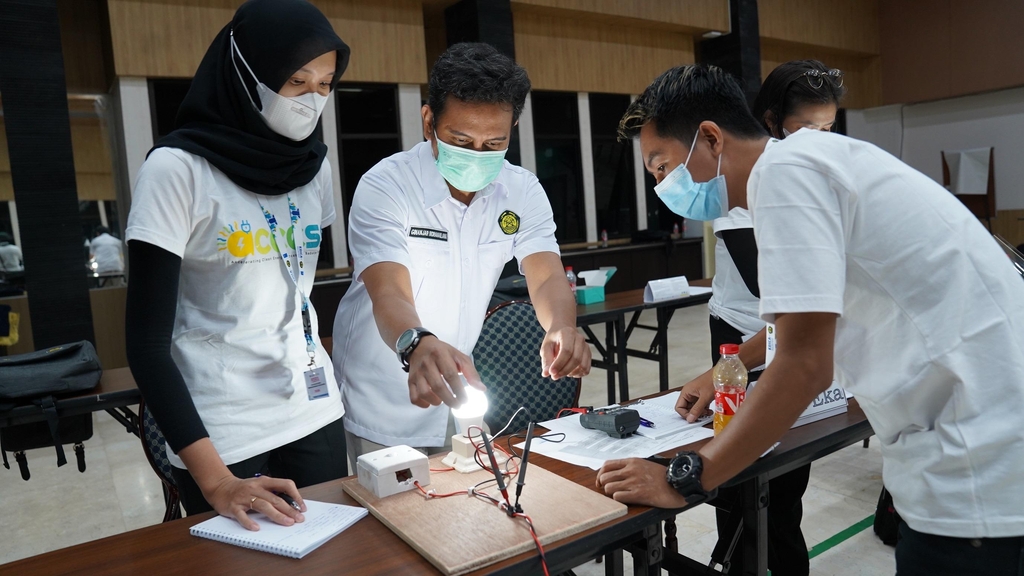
[126,0,349,530]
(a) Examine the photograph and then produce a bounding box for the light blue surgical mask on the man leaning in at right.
[654,132,729,220]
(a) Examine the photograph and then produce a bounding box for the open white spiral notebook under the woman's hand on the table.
[189,500,367,558]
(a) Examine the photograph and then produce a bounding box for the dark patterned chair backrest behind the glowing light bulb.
[473,301,580,433]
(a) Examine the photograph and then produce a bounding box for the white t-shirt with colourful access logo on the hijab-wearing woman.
[125,148,345,467]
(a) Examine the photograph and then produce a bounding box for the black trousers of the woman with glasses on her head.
[710,316,811,576]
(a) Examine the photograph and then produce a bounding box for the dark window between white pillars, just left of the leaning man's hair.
[590,94,636,238]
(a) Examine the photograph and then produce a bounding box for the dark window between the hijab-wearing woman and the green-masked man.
[333,84,401,268]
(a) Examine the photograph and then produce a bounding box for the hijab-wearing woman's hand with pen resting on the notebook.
[203,476,306,531]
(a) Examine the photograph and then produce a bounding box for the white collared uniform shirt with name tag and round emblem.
[334,142,558,447]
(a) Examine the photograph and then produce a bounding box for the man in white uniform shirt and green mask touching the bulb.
[334,43,591,462]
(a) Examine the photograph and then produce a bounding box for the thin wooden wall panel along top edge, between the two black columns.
[512,0,729,34]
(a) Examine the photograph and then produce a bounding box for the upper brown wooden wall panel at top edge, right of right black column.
[758,0,880,55]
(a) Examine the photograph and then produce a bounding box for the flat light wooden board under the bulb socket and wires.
[342,455,626,575]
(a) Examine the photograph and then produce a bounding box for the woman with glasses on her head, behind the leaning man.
[676,60,846,576]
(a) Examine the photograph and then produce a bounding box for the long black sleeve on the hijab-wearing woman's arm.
[125,240,209,452]
